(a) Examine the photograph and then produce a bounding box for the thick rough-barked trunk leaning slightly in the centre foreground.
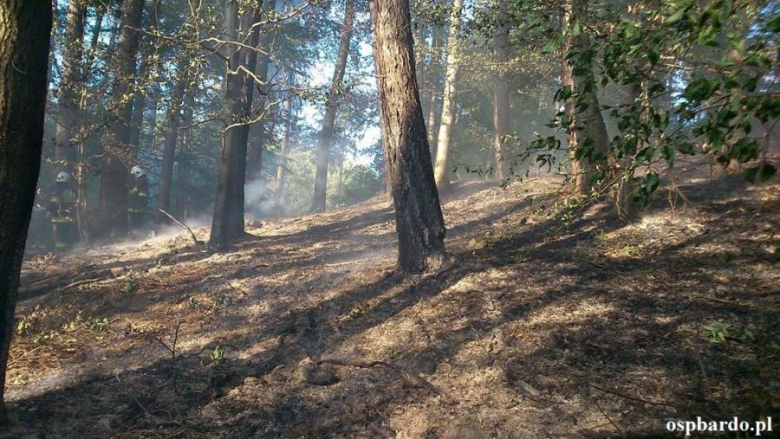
[370,0,448,272]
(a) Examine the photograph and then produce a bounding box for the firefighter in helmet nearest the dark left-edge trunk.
[47,172,79,251]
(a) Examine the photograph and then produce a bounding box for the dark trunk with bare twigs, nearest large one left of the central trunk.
[209,0,260,251]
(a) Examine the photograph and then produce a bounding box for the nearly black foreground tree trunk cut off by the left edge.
[0,0,52,424]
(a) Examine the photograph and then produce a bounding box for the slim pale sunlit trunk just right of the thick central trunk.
[493,0,512,180]
